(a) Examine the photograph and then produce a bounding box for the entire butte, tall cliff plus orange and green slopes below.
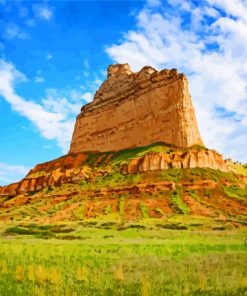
[0,64,247,225]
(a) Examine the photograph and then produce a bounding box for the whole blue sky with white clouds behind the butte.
[0,0,247,186]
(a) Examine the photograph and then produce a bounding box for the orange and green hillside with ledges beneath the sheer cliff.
[0,143,247,229]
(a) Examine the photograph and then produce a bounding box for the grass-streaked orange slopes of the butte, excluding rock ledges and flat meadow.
[0,144,247,229]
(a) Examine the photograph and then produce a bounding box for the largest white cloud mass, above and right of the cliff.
[106,0,247,162]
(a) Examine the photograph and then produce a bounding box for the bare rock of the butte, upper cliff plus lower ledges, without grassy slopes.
[0,64,234,196]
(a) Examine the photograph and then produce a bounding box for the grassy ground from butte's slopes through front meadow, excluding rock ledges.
[0,144,247,296]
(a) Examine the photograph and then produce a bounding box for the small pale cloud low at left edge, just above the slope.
[0,162,29,185]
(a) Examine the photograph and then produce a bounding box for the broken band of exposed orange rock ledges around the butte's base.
[0,149,229,196]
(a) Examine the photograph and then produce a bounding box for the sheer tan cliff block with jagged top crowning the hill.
[70,64,203,153]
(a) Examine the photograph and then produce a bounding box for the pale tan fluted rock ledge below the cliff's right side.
[121,150,229,174]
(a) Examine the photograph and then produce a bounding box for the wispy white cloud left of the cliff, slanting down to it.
[0,60,89,153]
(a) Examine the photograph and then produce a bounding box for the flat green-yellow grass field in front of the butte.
[0,222,247,296]
